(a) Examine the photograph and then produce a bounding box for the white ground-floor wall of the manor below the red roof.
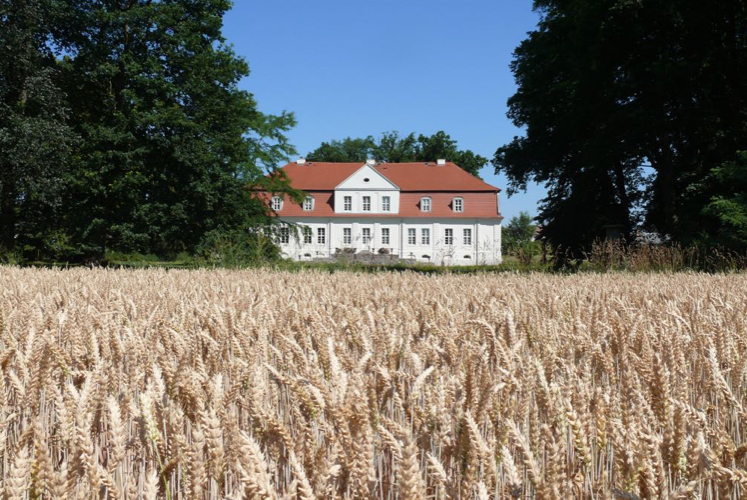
[280,217,501,265]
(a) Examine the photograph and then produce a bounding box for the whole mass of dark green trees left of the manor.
[0,0,295,259]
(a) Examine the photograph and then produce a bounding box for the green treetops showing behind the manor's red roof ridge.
[307,131,488,177]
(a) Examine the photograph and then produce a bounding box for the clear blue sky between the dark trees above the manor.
[224,0,544,219]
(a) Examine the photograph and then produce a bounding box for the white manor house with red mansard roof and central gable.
[267,158,503,265]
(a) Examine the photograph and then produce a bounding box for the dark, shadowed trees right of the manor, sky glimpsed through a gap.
[493,0,747,253]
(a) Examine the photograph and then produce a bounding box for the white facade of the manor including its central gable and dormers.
[271,161,502,265]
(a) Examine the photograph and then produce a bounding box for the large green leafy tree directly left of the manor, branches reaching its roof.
[61,0,295,256]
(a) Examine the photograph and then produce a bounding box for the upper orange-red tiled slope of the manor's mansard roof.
[283,162,500,193]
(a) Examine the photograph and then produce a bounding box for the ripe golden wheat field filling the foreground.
[0,267,747,500]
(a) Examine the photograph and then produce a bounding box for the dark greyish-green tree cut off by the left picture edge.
[0,0,74,251]
